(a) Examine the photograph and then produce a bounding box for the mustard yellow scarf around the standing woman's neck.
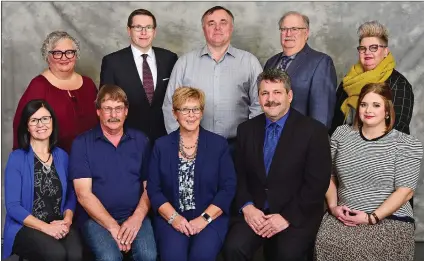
[340,53,396,117]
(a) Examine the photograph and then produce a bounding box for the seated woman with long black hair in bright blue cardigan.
[2,100,82,261]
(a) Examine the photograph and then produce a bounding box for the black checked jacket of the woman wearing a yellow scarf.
[329,70,414,135]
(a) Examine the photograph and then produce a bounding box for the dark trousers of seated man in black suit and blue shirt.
[223,216,319,261]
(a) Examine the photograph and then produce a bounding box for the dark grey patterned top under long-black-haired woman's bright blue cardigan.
[32,157,63,223]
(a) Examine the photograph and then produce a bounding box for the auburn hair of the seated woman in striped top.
[353,82,395,133]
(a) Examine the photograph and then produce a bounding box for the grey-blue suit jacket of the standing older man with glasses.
[264,44,337,128]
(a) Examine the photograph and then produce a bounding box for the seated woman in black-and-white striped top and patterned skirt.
[315,83,423,261]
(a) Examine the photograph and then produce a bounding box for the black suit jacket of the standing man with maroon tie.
[100,46,178,142]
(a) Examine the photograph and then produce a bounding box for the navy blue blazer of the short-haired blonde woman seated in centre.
[147,127,236,241]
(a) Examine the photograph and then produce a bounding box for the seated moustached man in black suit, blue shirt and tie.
[224,69,331,261]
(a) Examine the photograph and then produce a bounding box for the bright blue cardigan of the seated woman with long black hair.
[2,146,76,259]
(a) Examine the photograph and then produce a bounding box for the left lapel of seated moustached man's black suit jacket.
[252,114,266,184]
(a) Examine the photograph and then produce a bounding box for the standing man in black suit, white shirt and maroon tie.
[100,9,178,142]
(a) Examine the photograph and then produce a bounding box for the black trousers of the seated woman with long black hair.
[13,223,83,261]
